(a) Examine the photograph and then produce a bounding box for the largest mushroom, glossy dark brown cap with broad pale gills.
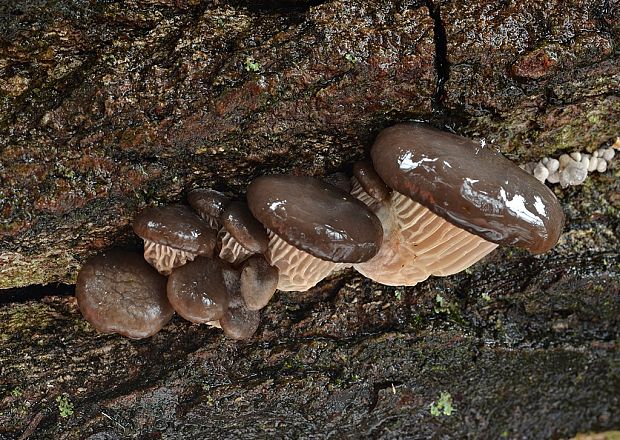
[353,123,564,285]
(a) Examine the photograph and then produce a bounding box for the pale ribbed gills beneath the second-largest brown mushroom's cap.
[266,229,351,292]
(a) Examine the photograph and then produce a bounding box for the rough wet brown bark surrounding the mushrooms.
[0,0,620,439]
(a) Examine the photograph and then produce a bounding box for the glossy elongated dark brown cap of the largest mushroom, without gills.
[371,123,564,253]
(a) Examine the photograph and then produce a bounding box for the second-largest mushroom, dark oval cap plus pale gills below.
[247,176,383,291]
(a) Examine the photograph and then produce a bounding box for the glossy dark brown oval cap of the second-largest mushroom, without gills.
[247,176,383,263]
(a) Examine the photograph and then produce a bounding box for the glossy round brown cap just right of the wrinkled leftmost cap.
[167,257,229,324]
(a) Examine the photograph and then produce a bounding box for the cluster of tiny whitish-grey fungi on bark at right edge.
[521,138,620,188]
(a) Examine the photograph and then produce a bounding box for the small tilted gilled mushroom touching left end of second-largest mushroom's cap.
[219,202,269,264]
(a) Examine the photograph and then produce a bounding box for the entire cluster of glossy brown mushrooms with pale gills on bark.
[76,123,564,339]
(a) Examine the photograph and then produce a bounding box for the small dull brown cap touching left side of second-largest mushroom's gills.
[240,254,278,310]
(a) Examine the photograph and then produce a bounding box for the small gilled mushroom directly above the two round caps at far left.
[133,205,217,275]
